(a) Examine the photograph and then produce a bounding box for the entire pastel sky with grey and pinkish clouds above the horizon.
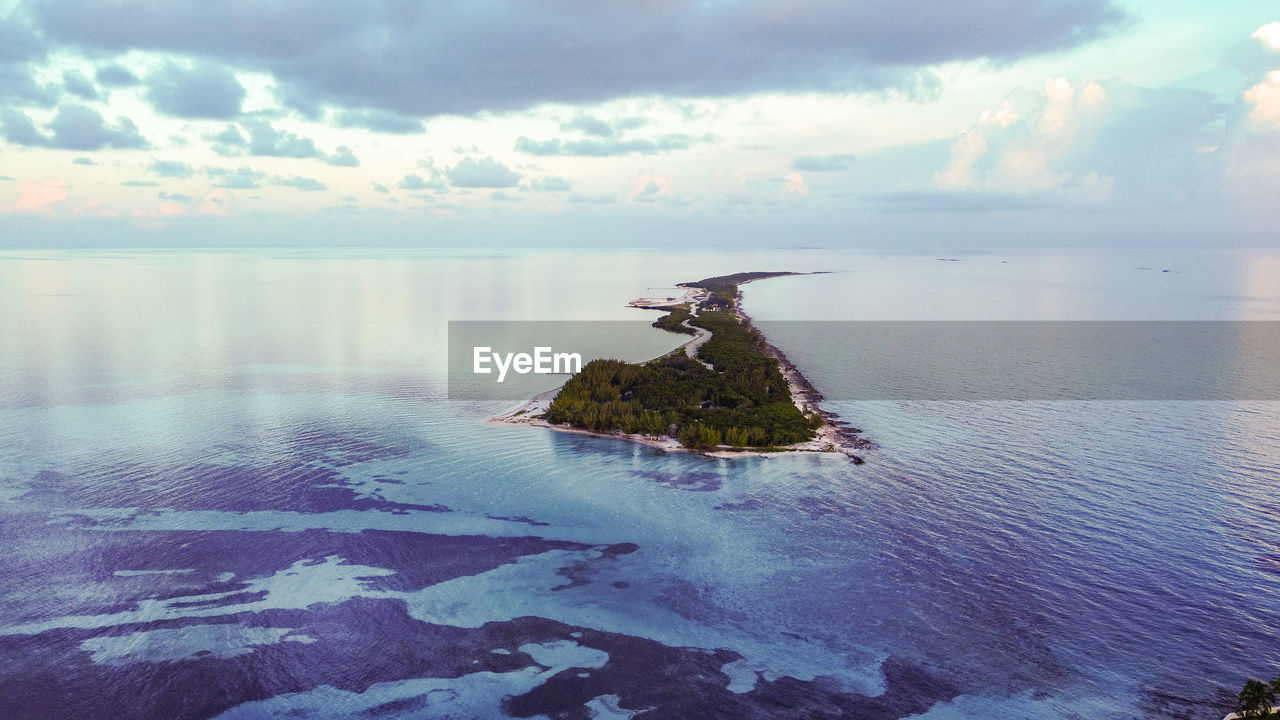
[0,0,1280,249]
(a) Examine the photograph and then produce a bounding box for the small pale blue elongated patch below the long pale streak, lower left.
[81,625,315,664]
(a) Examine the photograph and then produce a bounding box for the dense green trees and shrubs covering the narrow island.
[547,273,822,448]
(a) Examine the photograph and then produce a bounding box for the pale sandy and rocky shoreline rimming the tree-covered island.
[485,273,876,465]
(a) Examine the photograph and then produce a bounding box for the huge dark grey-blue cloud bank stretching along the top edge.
[32,0,1126,117]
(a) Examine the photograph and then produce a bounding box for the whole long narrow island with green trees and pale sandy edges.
[494,272,872,464]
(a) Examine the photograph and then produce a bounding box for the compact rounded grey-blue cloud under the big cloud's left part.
[146,61,244,120]
